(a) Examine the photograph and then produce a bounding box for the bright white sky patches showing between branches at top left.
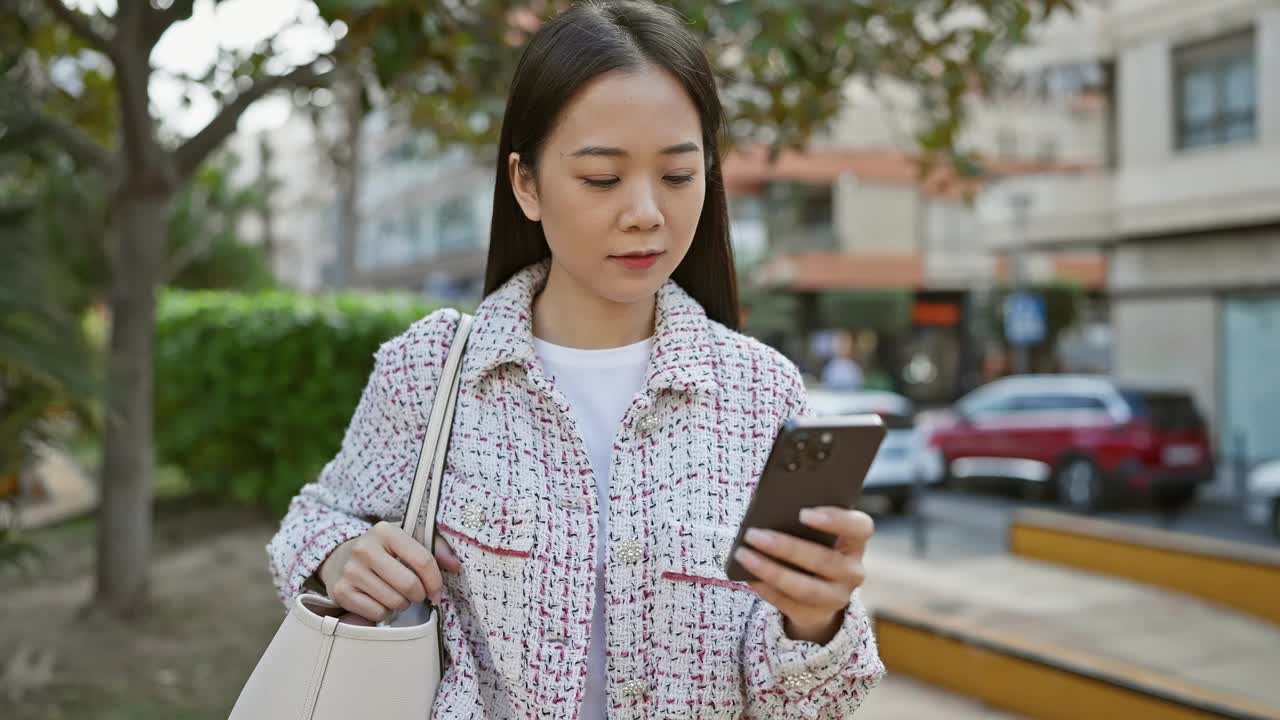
[64,0,333,136]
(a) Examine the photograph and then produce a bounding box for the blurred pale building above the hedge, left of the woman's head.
[232,104,493,302]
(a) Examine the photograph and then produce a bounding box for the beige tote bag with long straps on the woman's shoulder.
[229,315,472,720]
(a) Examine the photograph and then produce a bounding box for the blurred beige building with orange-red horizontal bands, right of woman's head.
[724,6,1111,402]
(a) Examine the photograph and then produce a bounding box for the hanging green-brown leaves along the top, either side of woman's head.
[316,0,1073,154]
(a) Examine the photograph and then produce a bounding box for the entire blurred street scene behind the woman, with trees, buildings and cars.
[0,0,1280,720]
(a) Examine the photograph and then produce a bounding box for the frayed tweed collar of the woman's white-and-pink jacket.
[462,260,719,391]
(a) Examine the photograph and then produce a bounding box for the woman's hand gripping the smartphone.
[736,507,876,644]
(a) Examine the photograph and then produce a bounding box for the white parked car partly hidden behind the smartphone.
[809,387,923,512]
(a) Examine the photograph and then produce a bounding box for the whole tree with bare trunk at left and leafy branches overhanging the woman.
[0,0,1069,614]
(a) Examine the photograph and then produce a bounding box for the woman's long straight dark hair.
[485,0,739,328]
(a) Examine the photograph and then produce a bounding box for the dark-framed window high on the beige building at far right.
[1174,29,1258,149]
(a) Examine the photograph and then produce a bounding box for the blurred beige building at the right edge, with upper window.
[988,0,1280,460]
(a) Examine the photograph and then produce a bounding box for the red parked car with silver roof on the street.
[920,375,1213,512]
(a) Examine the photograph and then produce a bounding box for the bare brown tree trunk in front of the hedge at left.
[93,190,173,618]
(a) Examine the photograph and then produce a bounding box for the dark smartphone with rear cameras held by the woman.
[724,414,887,583]
